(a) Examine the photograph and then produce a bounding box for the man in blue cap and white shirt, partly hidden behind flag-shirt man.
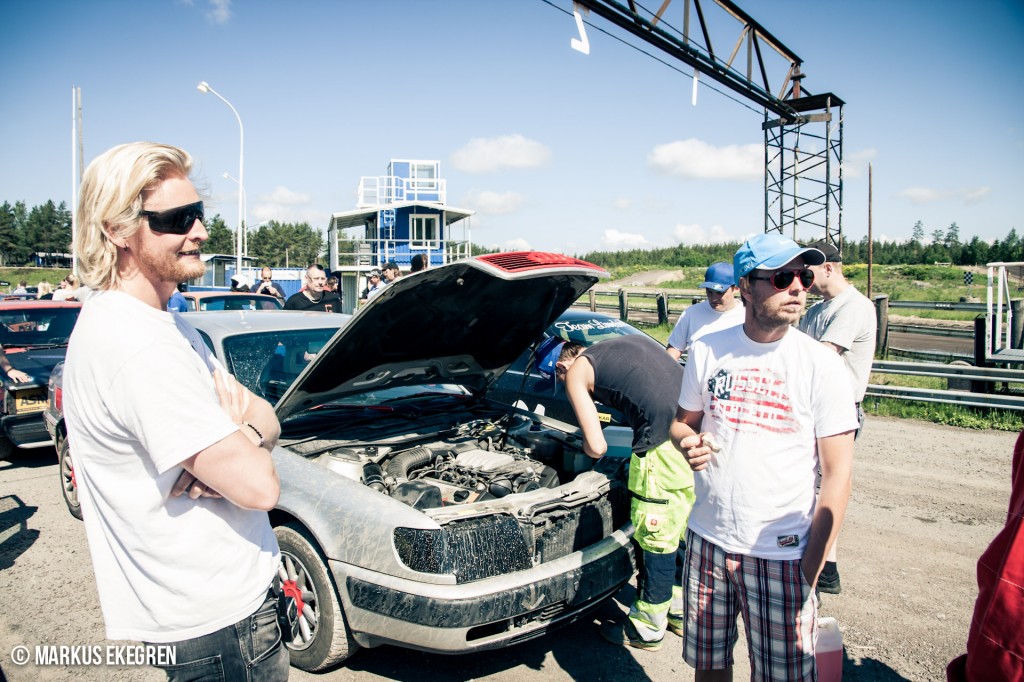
[668,261,743,360]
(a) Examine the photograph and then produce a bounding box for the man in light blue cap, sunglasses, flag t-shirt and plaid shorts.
[672,233,857,682]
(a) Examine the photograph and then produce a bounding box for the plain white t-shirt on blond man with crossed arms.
[63,292,280,643]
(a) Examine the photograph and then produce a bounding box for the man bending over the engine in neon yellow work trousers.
[538,335,693,651]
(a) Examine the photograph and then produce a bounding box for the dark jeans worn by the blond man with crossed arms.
[144,593,289,682]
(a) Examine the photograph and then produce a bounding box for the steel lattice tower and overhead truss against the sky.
[573,0,845,250]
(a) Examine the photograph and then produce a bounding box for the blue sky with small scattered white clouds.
[0,0,1024,254]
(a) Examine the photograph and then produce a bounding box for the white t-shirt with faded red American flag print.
[679,326,857,559]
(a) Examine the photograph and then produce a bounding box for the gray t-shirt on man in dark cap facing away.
[800,285,879,402]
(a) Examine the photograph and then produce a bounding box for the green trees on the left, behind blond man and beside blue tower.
[0,201,324,267]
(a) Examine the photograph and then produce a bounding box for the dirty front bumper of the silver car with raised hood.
[331,530,636,653]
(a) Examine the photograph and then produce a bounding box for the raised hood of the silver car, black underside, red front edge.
[275,252,608,419]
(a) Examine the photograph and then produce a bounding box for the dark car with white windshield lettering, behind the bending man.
[488,308,664,428]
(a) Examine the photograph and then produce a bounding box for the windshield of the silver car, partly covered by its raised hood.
[223,327,338,402]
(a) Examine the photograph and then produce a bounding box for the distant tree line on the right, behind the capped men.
[580,220,1024,269]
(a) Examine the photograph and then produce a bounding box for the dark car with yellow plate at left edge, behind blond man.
[0,300,82,460]
